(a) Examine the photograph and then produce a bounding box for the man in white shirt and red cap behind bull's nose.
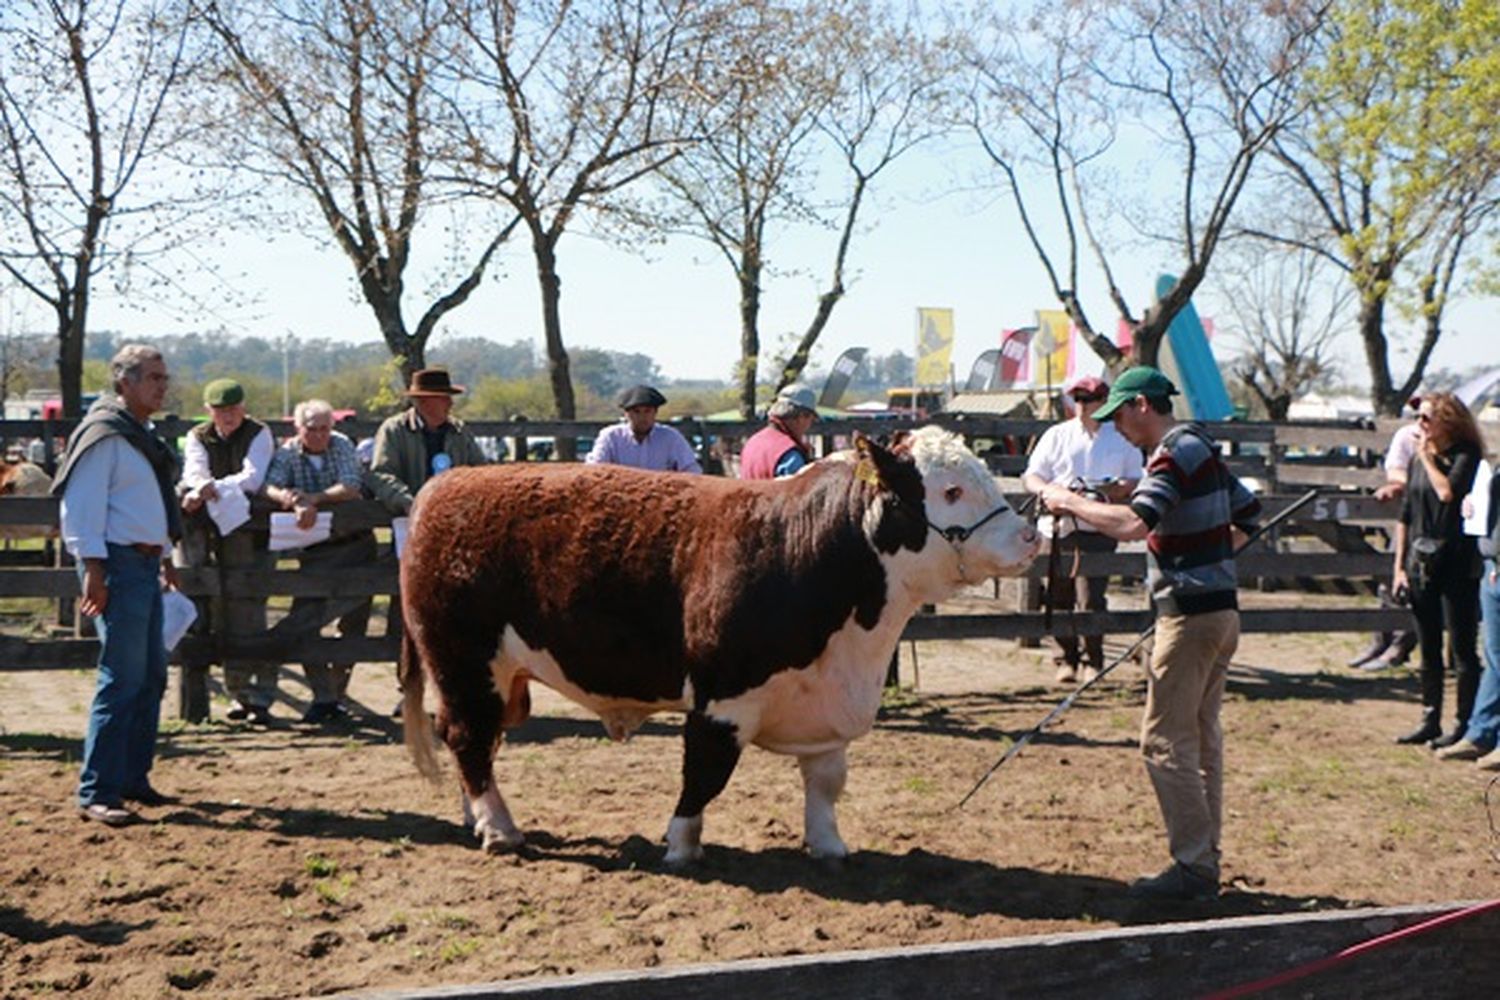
[1022,375,1142,684]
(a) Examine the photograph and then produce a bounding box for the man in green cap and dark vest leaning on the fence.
[177,378,279,726]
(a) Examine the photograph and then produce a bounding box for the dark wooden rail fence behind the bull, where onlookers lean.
[0,415,1464,718]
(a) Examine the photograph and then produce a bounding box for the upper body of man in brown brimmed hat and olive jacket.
[365,367,486,516]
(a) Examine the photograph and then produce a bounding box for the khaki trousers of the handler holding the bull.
[1140,610,1239,879]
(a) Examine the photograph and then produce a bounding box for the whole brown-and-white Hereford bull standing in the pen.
[401,427,1038,865]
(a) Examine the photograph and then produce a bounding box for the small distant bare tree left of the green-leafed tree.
[1215,241,1355,420]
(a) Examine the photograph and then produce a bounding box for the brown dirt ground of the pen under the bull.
[0,595,1500,997]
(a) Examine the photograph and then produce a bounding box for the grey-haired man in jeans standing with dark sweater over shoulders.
[53,343,182,826]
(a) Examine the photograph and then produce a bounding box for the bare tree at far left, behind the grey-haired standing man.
[0,0,188,415]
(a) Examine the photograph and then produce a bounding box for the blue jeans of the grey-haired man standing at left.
[78,544,167,805]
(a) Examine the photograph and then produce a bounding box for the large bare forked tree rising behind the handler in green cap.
[959,0,1326,367]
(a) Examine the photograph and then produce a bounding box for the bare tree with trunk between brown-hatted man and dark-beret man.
[447,0,717,446]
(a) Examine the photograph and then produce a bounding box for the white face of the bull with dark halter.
[908,427,1041,583]
